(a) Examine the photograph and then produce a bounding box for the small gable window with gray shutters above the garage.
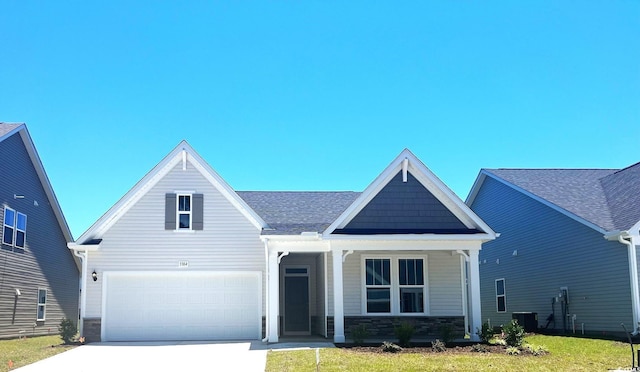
[164,194,204,230]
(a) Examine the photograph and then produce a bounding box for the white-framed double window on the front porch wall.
[364,257,427,314]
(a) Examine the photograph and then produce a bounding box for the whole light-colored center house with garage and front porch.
[69,141,496,342]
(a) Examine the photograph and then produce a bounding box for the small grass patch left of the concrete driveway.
[0,335,75,372]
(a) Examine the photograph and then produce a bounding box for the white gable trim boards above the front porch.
[323,149,496,239]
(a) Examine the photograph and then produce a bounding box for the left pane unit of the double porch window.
[365,258,391,313]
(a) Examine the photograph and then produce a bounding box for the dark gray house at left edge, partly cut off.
[0,122,80,338]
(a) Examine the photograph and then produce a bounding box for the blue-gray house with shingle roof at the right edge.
[466,163,640,335]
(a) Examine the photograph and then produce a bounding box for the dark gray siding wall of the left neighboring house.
[0,133,79,338]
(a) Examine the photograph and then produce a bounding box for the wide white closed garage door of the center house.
[102,272,262,341]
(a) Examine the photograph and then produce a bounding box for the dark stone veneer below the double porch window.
[327,316,465,339]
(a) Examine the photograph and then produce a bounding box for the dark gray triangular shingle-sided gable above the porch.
[344,172,468,232]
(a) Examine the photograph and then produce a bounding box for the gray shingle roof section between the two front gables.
[237,191,360,235]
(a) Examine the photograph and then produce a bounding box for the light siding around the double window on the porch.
[327,251,464,316]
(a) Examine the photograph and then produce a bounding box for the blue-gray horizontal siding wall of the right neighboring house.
[471,177,632,333]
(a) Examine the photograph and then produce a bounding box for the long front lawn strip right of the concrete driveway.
[267,335,631,372]
